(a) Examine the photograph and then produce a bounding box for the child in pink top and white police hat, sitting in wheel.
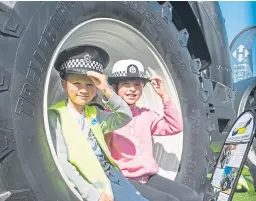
[106,60,201,201]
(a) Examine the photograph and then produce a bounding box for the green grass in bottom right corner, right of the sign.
[232,168,256,201]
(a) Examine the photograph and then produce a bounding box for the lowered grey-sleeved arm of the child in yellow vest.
[49,111,101,201]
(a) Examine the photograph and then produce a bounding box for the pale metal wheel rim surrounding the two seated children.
[43,18,183,194]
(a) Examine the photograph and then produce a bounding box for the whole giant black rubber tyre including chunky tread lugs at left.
[0,2,209,201]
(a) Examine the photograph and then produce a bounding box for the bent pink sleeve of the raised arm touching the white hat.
[151,100,183,135]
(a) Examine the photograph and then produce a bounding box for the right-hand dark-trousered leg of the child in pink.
[147,175,202,201]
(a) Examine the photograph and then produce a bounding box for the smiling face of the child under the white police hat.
[117,79,144,105]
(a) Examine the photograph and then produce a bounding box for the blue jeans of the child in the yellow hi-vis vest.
[109,168,148,201]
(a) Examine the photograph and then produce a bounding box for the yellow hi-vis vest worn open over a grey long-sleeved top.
[49,101,118,196]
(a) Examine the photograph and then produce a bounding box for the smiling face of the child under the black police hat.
[62,74,97,106]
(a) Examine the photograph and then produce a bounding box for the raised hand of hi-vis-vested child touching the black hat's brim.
[86,71,114,99]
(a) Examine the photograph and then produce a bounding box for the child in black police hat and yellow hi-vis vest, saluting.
[49,45,146,201]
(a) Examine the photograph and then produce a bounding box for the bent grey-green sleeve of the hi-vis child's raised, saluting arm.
[97,92,132,134]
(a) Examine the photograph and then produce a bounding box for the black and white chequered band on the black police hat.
[60,59,103,73]
